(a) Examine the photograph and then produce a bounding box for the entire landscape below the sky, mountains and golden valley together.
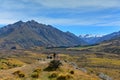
[0,20,120,80]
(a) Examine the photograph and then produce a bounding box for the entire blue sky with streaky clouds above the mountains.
[0,0,120,35]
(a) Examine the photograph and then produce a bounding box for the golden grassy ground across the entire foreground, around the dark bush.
[0,49,120,80]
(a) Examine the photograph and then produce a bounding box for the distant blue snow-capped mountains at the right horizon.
[79,31,120,45]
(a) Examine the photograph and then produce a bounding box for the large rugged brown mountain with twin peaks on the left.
[0,20,84,49]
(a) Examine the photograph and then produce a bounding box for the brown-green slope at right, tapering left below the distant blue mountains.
[68,38,120,54]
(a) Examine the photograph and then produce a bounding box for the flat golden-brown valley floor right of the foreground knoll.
[66,53,120,80]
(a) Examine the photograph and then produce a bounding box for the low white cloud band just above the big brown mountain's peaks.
[0,16,103,26]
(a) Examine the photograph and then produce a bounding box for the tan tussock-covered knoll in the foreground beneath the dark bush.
[0,61,99,80]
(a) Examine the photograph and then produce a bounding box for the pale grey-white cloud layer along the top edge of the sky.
[0,0,120,10]
